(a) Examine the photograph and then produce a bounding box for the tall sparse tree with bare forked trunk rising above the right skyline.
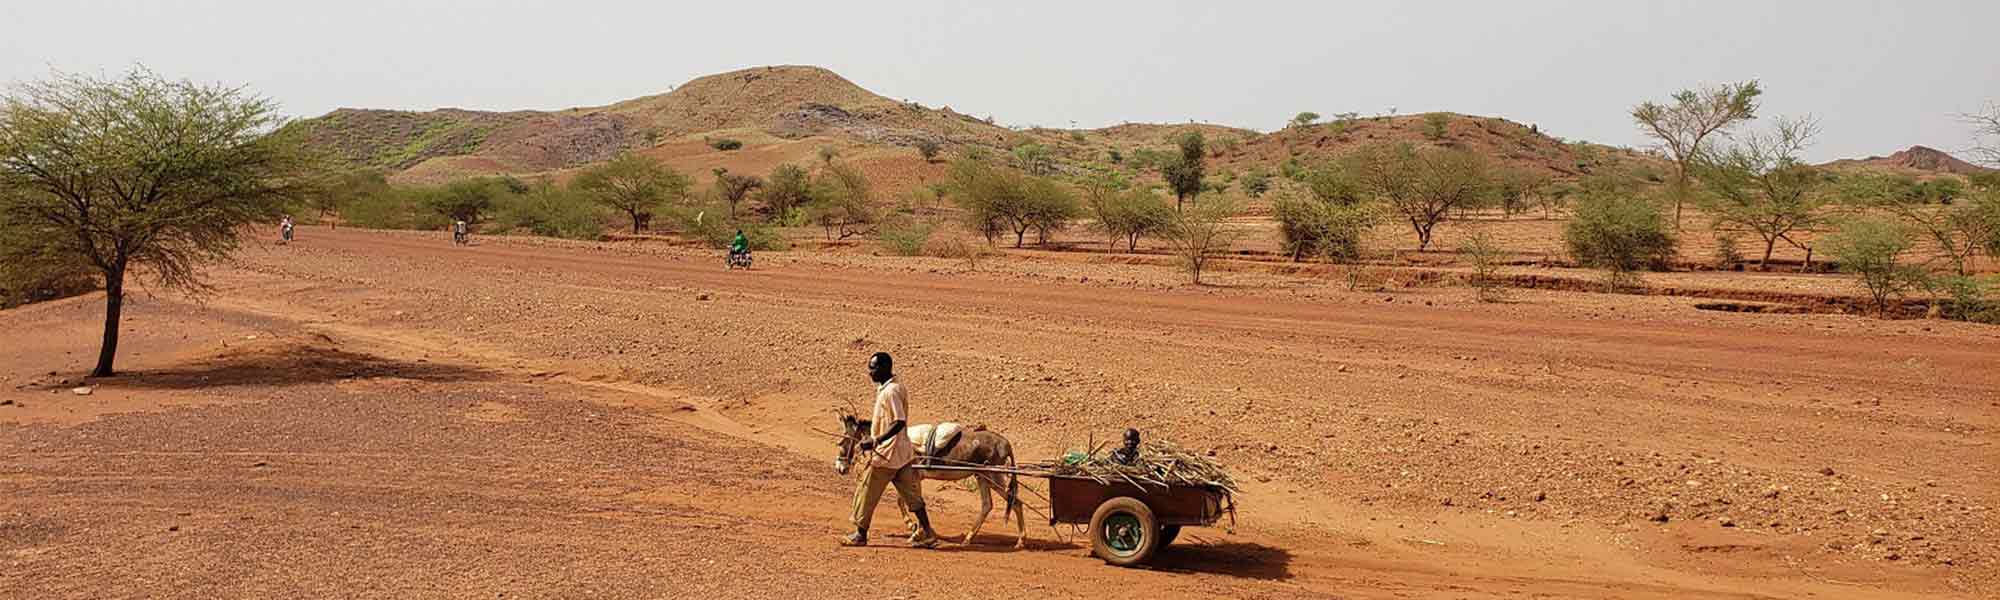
[1632,80,1764,228]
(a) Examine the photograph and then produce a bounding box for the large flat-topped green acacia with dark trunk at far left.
[0,68,316,376]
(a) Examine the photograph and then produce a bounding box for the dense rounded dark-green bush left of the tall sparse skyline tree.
[1562,194,1678,288]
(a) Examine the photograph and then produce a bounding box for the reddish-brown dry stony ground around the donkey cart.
[0,228,2000,598]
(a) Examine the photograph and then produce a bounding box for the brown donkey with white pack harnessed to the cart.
[834,414,1028,548]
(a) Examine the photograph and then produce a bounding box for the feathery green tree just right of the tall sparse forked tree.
[1694,118,1830,268]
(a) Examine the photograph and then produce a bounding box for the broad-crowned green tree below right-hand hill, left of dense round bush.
[1348,144,1498,250]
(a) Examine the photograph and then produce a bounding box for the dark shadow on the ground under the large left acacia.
[90,344,496,390]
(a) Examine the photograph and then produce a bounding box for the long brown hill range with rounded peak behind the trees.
[296,66,1652,192]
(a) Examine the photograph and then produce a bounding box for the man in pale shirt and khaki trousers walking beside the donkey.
[840,352,938,548]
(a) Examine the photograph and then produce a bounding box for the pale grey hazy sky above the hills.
[0,0,2000,160]
